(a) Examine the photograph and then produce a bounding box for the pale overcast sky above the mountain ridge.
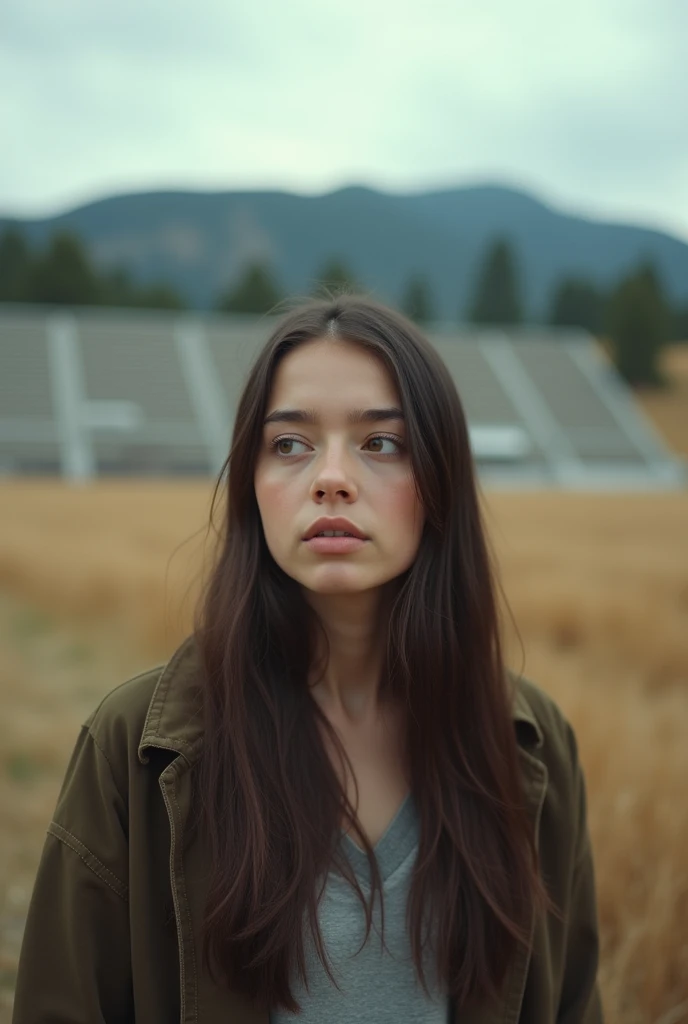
[0,0,688,240]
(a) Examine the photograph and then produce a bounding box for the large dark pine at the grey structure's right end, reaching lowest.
[608,262,671,385]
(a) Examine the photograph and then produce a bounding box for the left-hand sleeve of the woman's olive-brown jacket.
[12,725,134,1024]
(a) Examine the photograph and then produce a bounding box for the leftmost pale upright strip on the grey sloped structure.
[46,313,96,482]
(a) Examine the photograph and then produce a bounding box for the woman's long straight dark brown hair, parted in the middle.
[188,294,556,1013]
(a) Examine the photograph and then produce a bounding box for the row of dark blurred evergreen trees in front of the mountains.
[0,227,688,384]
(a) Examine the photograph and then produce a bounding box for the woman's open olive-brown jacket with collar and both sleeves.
[12,637,602,1024]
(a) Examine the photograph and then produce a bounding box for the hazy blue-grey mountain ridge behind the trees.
[0,183,688,321]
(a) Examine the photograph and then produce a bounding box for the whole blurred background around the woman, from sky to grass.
[0,0,688,1024]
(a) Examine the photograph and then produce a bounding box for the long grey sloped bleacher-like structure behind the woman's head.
[0,306,687,489]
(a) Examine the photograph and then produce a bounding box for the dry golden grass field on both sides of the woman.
[0,349,688,1024]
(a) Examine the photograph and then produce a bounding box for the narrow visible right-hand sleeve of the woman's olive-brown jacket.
[557,723,604,1024]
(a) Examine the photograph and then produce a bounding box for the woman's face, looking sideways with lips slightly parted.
[254,338,425,594]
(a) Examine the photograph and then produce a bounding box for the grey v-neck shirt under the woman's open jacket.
[269,793,449,1024]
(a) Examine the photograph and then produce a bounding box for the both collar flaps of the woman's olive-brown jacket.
[138,635,543,764]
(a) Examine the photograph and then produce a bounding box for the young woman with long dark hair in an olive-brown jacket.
[13,296,602,1024]
